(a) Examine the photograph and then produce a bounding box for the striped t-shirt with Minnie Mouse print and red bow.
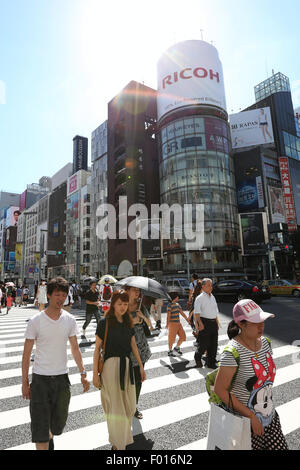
[220,336,276,427]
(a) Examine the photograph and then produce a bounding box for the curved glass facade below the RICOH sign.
[158,107,239,276]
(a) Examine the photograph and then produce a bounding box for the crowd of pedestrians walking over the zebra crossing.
[0,274,287,450]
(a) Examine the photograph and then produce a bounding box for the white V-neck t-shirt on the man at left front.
[25,310,78,375]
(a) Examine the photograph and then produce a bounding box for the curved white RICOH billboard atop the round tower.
[157,40,226,120]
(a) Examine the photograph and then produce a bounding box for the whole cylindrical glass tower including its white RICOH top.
[157,40,240,277]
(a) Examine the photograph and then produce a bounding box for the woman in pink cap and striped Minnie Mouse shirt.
[214,299,288,450]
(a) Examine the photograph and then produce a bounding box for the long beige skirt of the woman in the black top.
[101,357,136,450]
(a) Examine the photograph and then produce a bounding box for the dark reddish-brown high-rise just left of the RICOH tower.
[107,81,161,276]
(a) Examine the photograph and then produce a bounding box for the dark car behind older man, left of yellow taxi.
[213,279,271,303]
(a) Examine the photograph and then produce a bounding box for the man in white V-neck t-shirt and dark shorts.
[22,277,89,450]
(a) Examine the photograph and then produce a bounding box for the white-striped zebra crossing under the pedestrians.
[0,308,300,451]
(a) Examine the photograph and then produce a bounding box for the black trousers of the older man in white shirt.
[195,317,218,368]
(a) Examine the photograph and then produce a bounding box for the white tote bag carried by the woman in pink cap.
[207,404,251,450]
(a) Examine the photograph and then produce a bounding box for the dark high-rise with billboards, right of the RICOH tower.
[231,73,300,279]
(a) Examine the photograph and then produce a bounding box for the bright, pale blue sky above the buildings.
[0,0,300,192]
